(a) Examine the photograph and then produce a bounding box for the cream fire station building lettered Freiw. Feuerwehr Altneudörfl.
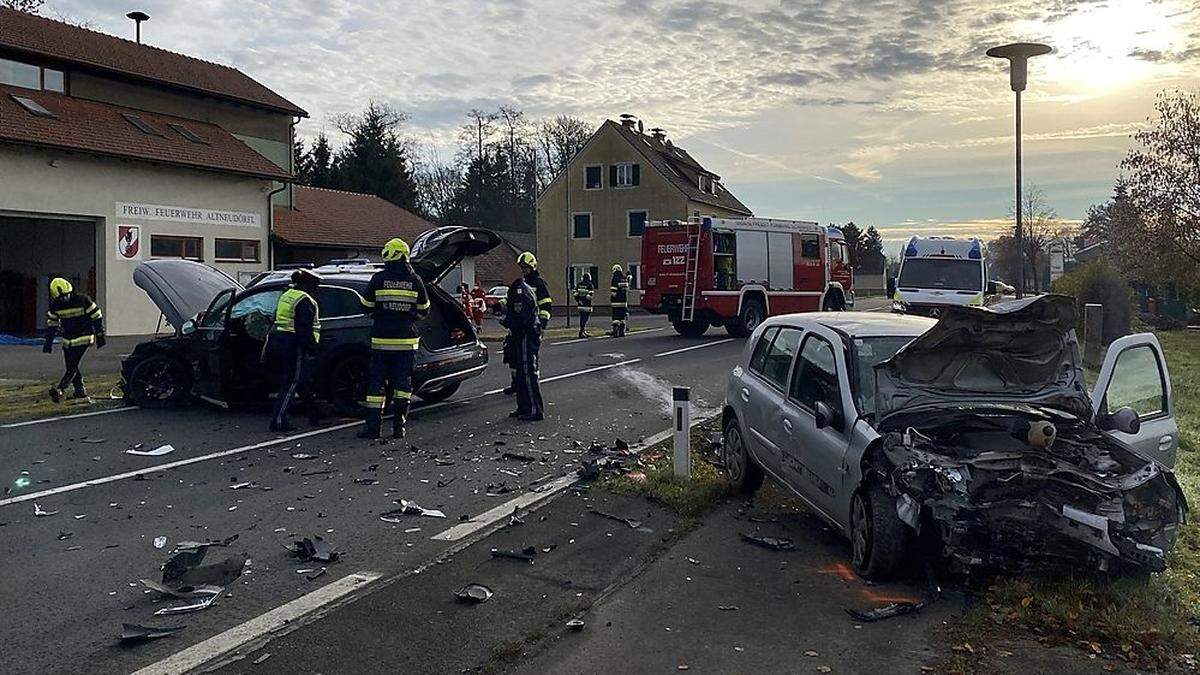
[0,8,306,335]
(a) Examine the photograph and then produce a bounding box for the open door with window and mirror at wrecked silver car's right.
[1092,333,1180,467]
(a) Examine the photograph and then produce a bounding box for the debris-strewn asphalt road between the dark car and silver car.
[0,314,743,673]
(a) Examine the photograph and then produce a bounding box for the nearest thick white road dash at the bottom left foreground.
[133,572,382,675]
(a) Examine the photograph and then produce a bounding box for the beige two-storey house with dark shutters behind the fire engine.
[536,115,752,306]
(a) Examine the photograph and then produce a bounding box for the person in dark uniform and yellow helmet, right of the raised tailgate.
[503,251,550,422]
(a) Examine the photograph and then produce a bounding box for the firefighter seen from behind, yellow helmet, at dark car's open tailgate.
[359,239,430,438]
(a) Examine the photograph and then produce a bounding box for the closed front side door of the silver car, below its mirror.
[773,330,851,522]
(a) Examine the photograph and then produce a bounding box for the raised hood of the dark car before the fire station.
[133,259,241,331]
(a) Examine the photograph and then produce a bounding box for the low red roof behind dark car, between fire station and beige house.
[275,185,433,247]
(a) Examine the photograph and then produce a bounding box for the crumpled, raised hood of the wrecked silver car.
[875,295,1092,420]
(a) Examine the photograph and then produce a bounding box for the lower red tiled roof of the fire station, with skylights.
[0,85,292,180]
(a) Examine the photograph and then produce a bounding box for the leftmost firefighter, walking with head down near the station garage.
[42,276,104,404]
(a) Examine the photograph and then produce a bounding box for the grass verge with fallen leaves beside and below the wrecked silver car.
[950,330,1200,671]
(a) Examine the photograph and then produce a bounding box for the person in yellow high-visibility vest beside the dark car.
[264,269,320,432]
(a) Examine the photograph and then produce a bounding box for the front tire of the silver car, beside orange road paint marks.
[850,483,911,581]
